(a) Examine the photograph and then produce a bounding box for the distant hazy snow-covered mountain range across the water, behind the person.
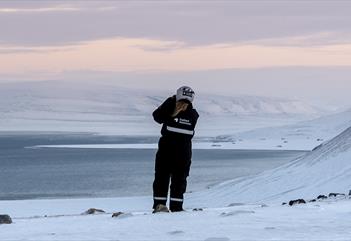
[0,81,326,136]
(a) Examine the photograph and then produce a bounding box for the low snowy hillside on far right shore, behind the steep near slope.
[214,109,351,150]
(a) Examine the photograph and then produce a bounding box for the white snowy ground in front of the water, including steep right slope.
[0,128,351,241]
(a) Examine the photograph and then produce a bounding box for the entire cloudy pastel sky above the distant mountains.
[0,0,351,105]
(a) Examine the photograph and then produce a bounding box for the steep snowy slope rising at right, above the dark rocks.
[192,127,351,206]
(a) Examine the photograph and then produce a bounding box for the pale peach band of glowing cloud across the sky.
[0,35,351,77]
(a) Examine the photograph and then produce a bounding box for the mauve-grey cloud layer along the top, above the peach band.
[0,1,351,46]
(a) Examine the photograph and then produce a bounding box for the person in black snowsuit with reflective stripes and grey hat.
[153,86,199,213]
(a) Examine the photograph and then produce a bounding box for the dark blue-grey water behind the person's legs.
[0,133,304,200]
